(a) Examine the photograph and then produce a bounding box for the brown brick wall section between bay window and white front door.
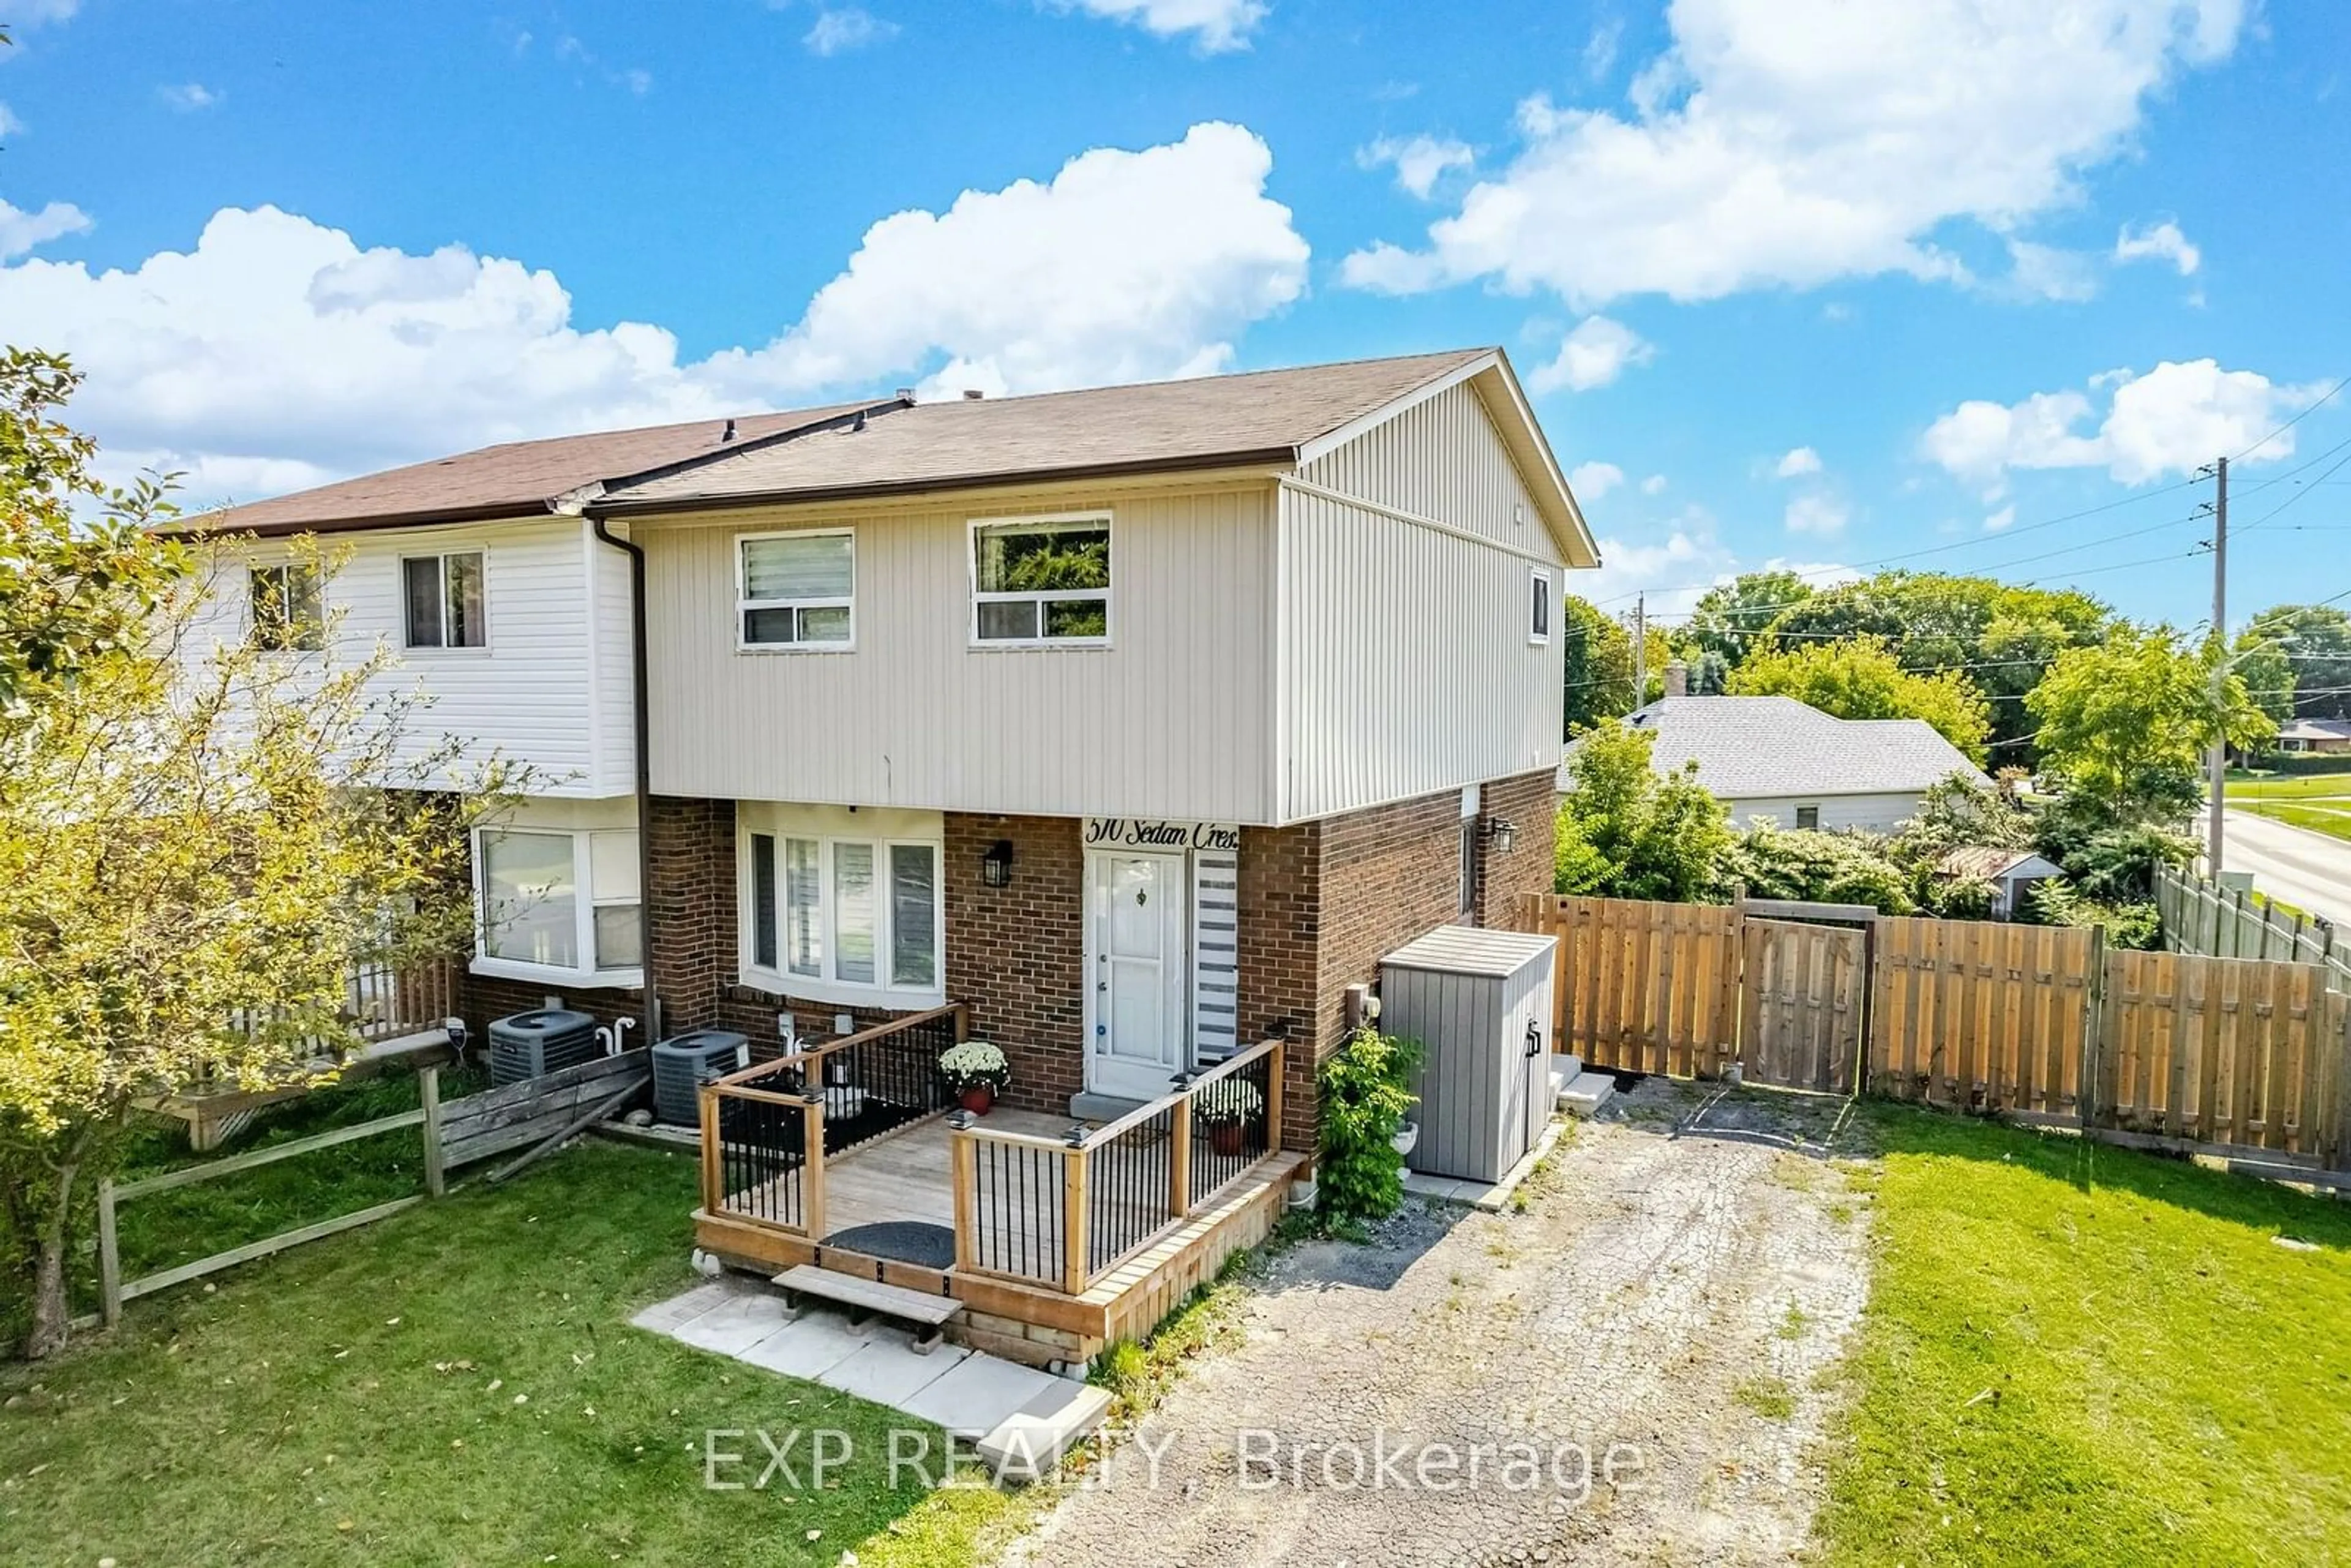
[943,811,1086,1114]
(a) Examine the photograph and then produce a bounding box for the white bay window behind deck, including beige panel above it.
[738,801,945,1006]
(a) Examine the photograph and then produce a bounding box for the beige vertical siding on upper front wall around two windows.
[639,484,1274,823]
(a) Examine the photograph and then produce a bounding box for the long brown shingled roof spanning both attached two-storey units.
[186,348,1599,566]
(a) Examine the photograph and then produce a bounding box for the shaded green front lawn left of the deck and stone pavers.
[0,1142,1021,1568]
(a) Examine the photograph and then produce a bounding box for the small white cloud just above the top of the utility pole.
[1921,359,2323,493]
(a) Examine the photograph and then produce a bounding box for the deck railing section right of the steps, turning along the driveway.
[954,1039,1284,1296]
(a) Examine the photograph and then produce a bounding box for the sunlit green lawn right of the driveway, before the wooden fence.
[1820,1107,2351,1566]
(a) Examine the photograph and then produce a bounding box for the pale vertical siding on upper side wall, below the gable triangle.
[1281,491,1564,820]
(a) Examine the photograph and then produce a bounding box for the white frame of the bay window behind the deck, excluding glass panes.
[736,811,948,1011]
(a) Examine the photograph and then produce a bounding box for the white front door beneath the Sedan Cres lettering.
[1086,851,1185,1100]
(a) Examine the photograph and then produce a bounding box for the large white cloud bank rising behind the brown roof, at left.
[0,124,1307,503]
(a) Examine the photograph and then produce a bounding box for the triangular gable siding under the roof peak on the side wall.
[1298,381,1564,562]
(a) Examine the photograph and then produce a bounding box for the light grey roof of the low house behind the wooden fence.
[1559,696,1991,801]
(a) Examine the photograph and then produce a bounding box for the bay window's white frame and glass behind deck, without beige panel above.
[745,832,940,992]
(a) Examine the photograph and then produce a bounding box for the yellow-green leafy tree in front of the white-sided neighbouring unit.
[0,358,496,1356]
